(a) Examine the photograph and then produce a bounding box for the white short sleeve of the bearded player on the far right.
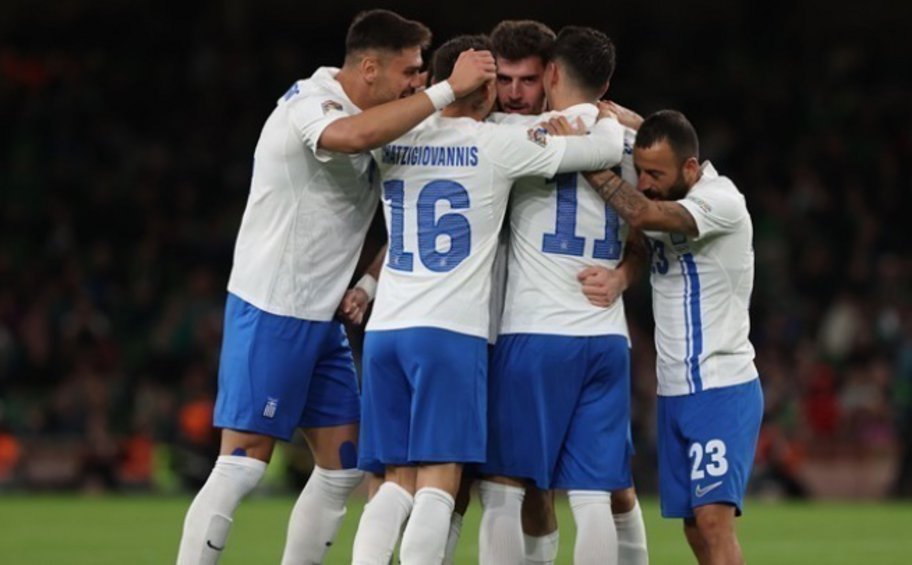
[677,177,748,240]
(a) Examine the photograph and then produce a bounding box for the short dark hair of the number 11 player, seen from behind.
[553,26,616,95]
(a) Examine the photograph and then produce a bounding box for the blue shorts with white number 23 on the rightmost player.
[657,379,763,518]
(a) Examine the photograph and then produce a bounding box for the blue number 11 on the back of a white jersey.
[542,173,621,260]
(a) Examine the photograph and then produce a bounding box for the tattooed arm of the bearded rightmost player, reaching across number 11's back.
[583,170,699,237]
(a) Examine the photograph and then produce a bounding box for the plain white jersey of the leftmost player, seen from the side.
[228,67,379,321]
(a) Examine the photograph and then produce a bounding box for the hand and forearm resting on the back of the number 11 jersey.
[577,229,649,308]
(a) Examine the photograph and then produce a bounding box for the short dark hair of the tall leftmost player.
[345,10,431,58]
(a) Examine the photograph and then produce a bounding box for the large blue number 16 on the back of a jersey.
[383,180,472,273]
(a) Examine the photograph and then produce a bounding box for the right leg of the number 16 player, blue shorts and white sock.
[400,328,488,565]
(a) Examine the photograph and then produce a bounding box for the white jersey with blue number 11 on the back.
[500,104,636,337]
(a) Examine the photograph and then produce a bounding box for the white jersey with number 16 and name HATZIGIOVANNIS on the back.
[367,115,623,339]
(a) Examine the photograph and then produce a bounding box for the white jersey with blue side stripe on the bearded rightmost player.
[646,162,757,396]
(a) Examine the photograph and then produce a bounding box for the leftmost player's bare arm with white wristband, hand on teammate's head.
[317,50,497,153]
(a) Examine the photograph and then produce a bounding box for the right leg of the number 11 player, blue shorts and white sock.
[554,335,633,564]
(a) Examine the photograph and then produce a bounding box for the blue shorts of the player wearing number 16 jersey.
[358,328,488,470]
